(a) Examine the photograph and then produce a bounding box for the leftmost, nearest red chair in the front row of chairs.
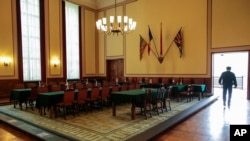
[55,89,75,119]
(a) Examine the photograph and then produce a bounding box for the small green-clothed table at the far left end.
[10,88,31,110]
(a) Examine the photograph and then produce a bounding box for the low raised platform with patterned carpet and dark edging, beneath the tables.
[0,96,217,141]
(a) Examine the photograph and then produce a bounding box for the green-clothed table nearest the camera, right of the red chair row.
[110,89,157,120]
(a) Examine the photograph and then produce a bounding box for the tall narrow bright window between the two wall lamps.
[65,2,80,79]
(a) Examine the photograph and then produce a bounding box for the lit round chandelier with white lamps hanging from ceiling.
[96,0,136,35]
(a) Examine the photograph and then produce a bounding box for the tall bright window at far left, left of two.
[20,0,41,81]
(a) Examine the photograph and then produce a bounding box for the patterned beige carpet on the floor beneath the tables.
[0,98,215,141]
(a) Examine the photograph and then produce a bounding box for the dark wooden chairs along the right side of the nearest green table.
[136,86,172,119]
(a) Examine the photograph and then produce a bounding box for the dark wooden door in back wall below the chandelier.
[107,59,124,81]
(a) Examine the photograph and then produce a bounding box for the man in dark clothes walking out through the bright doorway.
[219,66,237,107]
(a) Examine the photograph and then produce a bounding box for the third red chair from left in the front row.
[90,87,102,109]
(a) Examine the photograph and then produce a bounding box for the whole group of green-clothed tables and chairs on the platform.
[10,81,206,119]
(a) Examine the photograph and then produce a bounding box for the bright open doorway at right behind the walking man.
[212,51,248,99]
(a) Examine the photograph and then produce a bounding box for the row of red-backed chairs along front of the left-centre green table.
[55,86,119,119]
